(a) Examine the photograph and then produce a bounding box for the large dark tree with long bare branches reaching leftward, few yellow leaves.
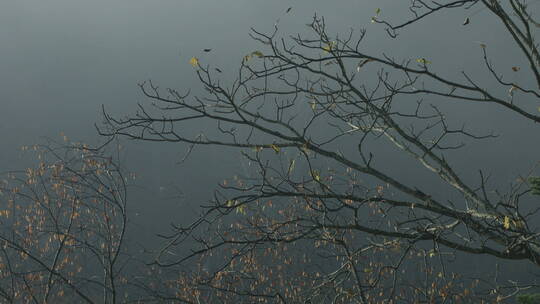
[99,0,540,303]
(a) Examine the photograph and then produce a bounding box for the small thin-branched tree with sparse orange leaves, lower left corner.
[0,142,130,303]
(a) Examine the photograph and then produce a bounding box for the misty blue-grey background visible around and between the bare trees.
[0,0,540,280]
